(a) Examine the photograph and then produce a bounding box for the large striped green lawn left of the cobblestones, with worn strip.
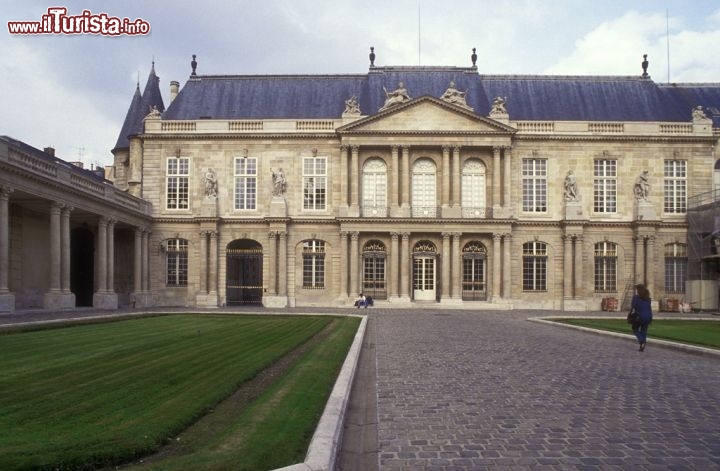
[0,315,359,470]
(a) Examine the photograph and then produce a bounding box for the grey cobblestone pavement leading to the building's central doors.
[372,310,720,471]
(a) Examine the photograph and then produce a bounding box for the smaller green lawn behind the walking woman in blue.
[557,318,720,348]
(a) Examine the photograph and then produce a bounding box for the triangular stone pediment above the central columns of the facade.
[338,96,515,134]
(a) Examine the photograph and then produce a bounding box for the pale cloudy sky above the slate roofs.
[0,0,720,168]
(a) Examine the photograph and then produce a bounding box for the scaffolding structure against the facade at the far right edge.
[685,189,720,311]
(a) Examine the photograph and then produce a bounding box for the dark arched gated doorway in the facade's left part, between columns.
[225,239,263,306]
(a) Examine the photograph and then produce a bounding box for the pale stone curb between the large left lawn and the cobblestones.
[274,316,367,471]
